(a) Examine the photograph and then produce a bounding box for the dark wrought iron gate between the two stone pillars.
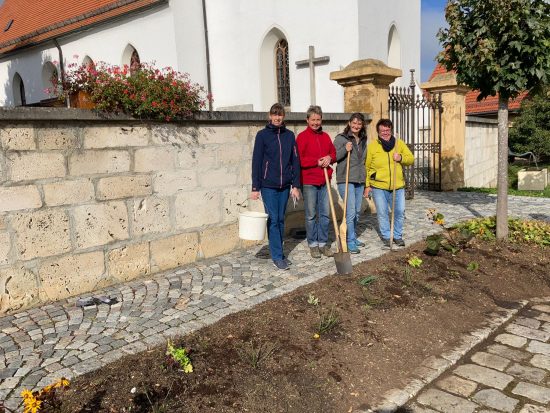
[389,69,443,199]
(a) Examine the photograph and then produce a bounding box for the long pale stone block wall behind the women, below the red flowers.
[0,108,348,313]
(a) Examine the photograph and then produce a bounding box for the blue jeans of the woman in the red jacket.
[302,185,330,248]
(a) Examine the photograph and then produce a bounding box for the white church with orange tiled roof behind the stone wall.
[0,0,421,112]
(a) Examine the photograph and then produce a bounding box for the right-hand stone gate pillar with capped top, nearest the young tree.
[421,73,471,191]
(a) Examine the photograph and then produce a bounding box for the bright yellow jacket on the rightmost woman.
[365,139,414,190]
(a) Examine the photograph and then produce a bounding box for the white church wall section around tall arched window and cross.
[207,0,357,112]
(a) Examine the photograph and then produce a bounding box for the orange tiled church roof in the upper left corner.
[0,0,167,55]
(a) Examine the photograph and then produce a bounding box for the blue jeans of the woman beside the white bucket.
[261,188,290,261]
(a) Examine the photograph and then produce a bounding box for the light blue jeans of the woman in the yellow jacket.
[372,188,405,239]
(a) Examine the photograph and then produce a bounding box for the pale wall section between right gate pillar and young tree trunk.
[464,116,498,188]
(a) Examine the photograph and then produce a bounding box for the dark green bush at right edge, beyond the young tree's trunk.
[509,86,550,160]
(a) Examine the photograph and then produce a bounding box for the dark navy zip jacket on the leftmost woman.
[252,123,300,191]
